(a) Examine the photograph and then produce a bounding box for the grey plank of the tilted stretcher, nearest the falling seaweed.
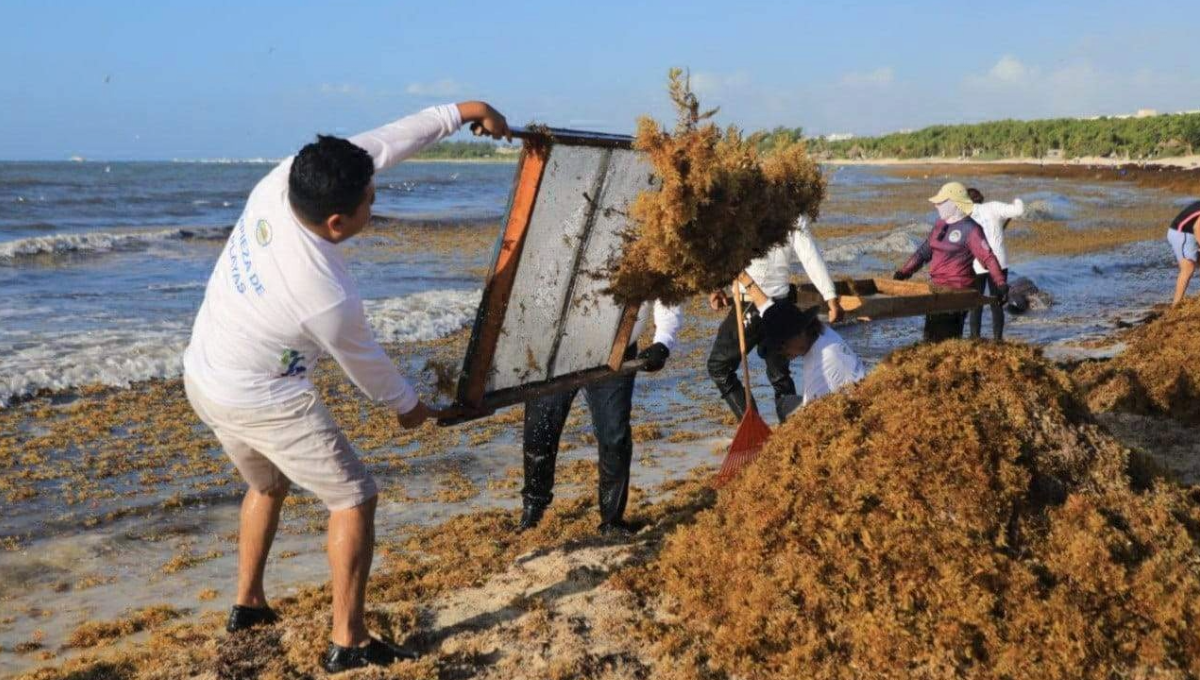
[550,150,652,377]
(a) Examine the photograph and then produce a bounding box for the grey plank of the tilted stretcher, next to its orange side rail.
[487,145,611,391]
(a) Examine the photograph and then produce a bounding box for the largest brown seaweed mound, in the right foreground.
[648,342,1200,679]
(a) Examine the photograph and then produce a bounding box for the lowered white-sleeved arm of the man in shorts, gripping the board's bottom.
[300,299,433,427]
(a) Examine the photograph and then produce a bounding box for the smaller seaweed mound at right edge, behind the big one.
[1075,296,1200,423]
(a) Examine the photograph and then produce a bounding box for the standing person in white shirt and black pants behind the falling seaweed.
[708,215,841,420]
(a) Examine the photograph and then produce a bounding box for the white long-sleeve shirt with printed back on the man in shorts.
[184,104,462,413]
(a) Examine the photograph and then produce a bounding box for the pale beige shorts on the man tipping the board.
[184,375,378,511]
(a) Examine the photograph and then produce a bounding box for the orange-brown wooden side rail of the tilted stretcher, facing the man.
[458,145,546,405]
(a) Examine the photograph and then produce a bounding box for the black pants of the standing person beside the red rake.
[708,297,796,422]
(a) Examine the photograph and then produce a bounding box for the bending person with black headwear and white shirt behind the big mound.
[742,273,866,422]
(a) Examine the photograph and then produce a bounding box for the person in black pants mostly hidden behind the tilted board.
[517,301,683,537]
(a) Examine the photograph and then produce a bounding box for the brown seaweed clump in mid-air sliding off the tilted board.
[608,68,826,303]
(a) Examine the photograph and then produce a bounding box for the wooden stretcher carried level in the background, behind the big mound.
[796,278,997,321]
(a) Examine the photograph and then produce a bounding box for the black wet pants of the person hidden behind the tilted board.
[521,345,637,522]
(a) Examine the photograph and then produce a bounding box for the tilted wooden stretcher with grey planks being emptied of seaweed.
[438,128,653,426]
